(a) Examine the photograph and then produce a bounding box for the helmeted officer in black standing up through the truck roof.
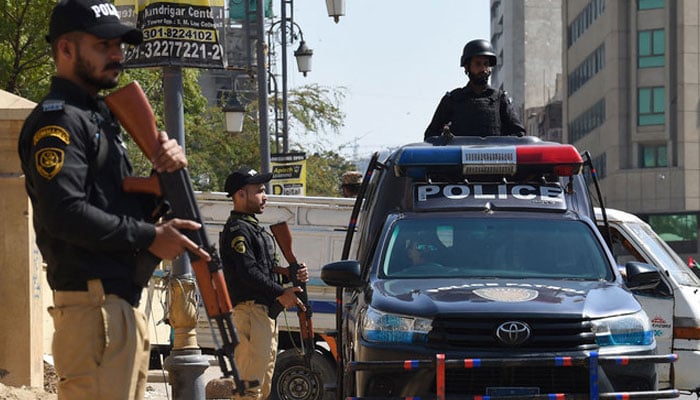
[425,39,525,139]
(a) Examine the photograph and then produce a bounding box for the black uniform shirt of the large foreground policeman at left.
[19,77,159,304]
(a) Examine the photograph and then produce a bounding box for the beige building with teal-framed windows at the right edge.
[561,0,700,256]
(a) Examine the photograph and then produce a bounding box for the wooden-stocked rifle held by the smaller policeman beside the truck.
[270,222,314,370]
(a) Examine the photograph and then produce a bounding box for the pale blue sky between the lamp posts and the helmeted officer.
[274,0,490,158]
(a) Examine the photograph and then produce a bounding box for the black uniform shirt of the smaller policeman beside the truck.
[219,210,284,307]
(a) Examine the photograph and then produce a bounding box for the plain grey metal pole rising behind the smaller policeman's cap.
[255,0,270,177]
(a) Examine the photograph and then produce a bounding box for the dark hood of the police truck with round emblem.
[371,278,641,318]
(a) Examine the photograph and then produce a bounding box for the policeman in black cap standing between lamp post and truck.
[219,166,308,400]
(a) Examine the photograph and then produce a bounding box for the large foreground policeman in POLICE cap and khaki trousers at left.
[18,0,210,400]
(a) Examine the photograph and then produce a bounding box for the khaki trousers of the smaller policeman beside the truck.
[233,301,277,400]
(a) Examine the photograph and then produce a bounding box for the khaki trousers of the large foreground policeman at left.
[49,280,150,400]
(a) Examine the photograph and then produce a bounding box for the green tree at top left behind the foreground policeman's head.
[0,0,56,101]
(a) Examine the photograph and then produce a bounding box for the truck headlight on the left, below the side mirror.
[361,307,433,343]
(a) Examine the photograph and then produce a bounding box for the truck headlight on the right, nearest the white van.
[592,311,654,347]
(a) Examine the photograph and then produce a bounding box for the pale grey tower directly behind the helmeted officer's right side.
[490,0,562,121]
